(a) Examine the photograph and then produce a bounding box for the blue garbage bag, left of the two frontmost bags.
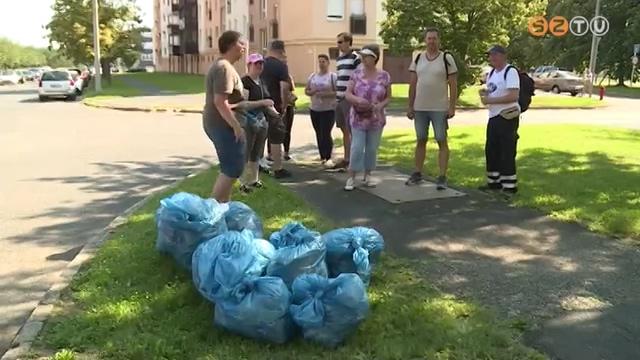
[214,276,296,344]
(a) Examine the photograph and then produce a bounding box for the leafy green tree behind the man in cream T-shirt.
[380,0,546,88]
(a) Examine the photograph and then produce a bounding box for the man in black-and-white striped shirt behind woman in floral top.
[334,32,360,171]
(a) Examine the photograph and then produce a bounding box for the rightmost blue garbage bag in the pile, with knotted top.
[323,227,384,286]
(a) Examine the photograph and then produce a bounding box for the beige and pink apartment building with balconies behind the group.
[154,0,385,82]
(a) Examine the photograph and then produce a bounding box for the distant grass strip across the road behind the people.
[85,73,603,111]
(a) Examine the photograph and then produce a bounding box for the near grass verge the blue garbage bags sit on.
[39,170,544,360]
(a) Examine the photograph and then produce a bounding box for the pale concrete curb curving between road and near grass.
[0,168,211,360]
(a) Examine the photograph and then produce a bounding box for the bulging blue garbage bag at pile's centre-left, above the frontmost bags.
[192,230,275,302]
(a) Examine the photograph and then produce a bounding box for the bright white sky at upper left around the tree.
[0,0,153,47]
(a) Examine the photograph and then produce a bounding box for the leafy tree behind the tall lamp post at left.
[47,0,141,79]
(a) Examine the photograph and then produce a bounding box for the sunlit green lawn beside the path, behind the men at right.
[380,123,640,240]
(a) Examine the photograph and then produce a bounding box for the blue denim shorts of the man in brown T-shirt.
[204,125,247,179]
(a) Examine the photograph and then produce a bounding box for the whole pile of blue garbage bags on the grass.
[156,193,384,348]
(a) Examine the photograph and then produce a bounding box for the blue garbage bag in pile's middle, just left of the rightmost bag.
[267,222,328,286]
